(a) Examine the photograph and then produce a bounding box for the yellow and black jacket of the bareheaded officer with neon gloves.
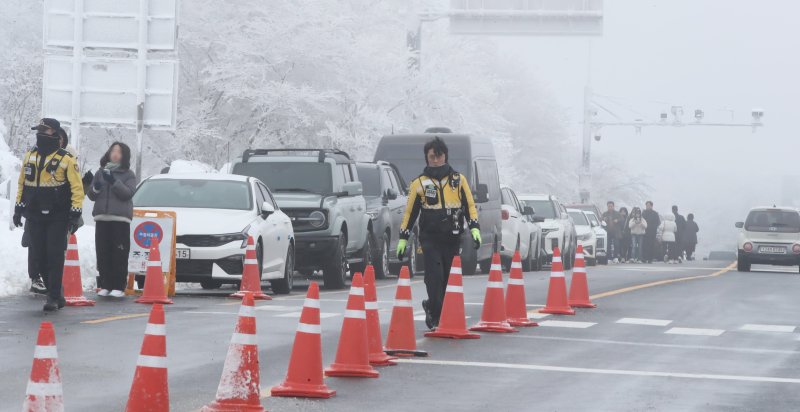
[400,171,480,239]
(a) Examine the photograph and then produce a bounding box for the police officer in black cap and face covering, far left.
[13,118,84,311]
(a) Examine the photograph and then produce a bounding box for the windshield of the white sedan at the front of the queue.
[133,179,253,210]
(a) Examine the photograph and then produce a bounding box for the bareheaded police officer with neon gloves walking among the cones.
[397,137,481,329]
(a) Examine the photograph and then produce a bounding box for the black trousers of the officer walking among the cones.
[420,237,461,323]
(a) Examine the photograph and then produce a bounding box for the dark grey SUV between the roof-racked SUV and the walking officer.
[356,161,416,278]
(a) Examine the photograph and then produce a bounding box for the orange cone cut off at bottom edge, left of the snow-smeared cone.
[125,303,169,412]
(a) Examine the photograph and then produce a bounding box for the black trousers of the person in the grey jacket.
[94,222,131,291]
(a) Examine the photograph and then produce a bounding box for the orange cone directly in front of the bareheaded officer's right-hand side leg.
[425,256,481,339]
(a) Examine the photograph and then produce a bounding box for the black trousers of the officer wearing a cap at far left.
[28,219,68,299]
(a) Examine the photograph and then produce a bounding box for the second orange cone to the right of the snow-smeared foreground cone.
[325,273,380,378]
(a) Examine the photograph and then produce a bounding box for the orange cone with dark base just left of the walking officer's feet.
[384,266,428,357]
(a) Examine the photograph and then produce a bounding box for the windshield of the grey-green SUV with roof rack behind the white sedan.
[233,162,333,194]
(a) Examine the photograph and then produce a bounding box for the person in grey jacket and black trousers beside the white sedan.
[88,142,137,298]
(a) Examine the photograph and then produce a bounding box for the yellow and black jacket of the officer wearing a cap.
[16,148,84,218]
